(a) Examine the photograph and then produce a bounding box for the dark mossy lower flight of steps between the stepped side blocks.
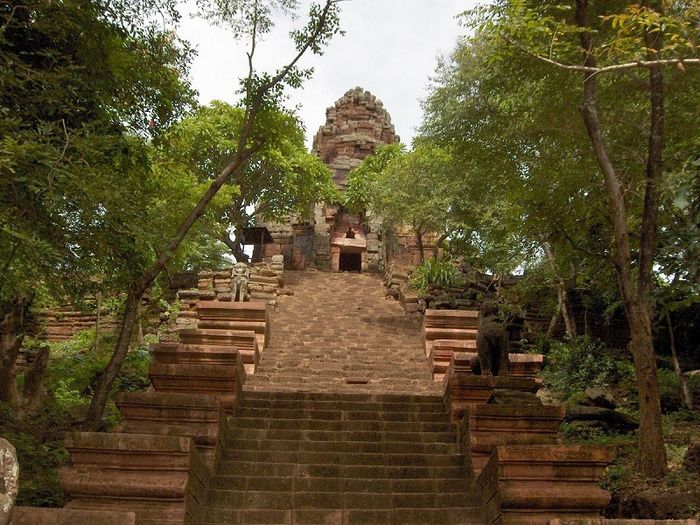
[206,392,484,525]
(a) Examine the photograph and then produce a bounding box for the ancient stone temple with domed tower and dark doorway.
[264,87,399,271]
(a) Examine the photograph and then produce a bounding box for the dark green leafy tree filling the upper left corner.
[0,0,193,414]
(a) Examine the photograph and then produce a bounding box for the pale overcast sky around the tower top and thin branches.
[179,0,476,145]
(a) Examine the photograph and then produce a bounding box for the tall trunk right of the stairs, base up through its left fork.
[576,0,667,477]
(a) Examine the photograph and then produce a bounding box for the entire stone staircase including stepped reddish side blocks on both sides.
[12,272,652,525]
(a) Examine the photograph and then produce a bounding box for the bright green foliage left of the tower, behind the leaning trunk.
[158,102,336,260]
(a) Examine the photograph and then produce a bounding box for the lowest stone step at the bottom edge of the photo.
[206,507,484,525]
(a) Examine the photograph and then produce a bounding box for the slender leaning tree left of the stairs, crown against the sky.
[84,0,340,430]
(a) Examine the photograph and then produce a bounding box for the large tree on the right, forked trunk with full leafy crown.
[418,0,699,476]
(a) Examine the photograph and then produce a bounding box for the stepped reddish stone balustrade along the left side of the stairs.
[51,298,254,525]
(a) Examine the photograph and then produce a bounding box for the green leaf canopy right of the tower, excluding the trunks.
[418,0,700,297]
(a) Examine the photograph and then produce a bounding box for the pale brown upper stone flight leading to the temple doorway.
[246,271,441,394]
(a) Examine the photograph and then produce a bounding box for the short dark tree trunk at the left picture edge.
[0,295,30,410]
